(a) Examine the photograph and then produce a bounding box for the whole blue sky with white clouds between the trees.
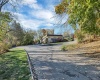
[3,0,74,34]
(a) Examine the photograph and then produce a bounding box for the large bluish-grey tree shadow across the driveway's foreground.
[31,55,100,80]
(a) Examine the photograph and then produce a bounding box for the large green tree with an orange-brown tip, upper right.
[55,0,100,35]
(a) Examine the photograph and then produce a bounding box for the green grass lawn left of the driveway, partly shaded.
[0,49,31,80]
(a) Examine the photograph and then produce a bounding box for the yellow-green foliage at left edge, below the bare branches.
[0,12,12,53]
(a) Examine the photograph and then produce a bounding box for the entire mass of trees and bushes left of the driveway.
[0,0,34,53]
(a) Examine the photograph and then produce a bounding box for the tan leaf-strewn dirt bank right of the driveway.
[67,41,100,59]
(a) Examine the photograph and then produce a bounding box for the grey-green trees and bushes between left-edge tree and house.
[9,21,35,46]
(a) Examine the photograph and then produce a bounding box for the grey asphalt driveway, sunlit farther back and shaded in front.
[17,45,100,80]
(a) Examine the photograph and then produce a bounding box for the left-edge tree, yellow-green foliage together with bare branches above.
[0,0,16,53]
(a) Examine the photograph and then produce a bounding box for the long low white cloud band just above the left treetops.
[14,13,53,30]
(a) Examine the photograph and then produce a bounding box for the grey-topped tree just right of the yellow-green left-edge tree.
[9,21,24,46]
